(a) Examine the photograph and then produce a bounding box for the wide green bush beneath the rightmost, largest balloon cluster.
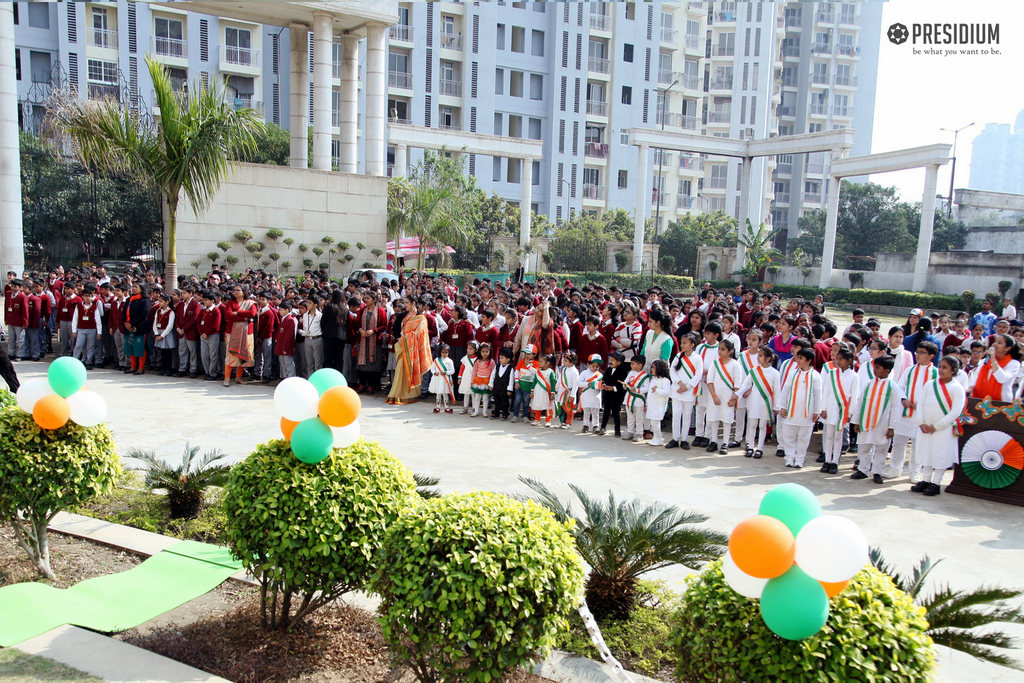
[673,563,936,683]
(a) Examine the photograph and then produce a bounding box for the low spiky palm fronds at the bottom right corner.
[870,548,1024,669]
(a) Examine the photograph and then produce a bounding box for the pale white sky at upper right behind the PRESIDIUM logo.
[870,0,1024,202]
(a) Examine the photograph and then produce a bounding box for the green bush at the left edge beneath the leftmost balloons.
[0,405,121,579]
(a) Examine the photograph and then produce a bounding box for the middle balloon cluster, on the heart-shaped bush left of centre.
[273,368,362,464]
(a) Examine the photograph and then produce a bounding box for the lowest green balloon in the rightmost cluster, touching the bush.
[761,566,828,640]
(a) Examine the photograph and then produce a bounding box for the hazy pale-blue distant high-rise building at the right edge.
[969,111,1024,195]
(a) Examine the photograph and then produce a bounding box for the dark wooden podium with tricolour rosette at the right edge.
[946,398,1024,507]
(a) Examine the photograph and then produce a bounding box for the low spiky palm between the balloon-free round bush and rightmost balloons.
[519,477,728,620]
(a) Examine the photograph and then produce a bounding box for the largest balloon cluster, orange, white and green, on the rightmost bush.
[722,483,868,640]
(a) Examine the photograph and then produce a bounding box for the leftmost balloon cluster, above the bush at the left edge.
[15,355,106,429]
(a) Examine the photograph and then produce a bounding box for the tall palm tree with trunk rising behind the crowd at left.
[50,57,265,282]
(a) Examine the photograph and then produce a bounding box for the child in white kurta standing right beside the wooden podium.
[910,357,967,496]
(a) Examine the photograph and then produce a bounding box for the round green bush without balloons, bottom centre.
[374,493,583,683]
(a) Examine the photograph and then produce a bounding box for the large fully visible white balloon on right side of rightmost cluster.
[794,515,868,584]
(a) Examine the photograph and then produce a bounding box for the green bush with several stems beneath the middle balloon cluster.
[224,439,416,630]
